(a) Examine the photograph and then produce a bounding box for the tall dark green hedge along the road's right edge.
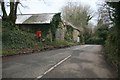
[106,2,120,66]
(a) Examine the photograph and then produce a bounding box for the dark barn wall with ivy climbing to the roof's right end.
[18,13,62,41]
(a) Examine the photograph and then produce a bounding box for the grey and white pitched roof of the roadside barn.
[16,13,55,24]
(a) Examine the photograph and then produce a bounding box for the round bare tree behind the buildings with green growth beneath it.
[62,2,93,43]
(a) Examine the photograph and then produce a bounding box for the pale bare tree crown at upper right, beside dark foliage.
[98,2,115,25]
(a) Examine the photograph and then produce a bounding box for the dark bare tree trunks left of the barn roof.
[1,0,20,24]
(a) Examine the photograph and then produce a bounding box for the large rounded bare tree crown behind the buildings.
[62,2,93,28]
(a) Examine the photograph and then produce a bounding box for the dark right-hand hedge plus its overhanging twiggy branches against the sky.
[98,2,120,68]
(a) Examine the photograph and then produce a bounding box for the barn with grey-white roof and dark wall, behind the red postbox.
[16,13,55,41]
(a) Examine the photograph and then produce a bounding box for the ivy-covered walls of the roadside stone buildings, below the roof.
[18,13,77,42]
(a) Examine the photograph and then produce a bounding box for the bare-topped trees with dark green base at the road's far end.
[87,2,114,45]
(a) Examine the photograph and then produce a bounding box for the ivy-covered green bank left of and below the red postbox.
[2,22,43,55]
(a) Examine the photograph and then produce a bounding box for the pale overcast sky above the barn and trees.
[0,0,101,25]
